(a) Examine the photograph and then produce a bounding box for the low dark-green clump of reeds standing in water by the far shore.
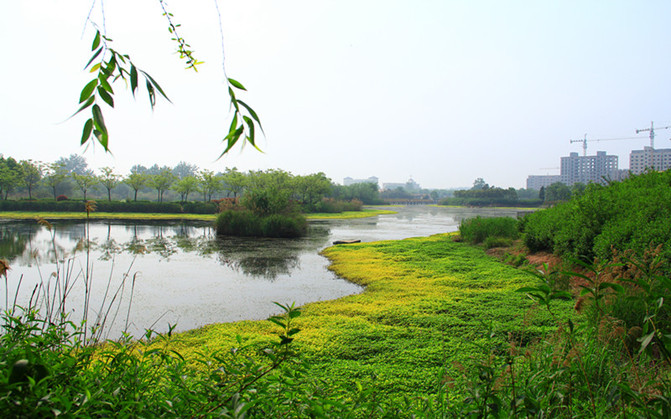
[216,210,307,238]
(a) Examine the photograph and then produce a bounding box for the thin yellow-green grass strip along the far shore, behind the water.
[0,209,395,222]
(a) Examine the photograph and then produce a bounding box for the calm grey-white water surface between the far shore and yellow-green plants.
[0,206,516,337]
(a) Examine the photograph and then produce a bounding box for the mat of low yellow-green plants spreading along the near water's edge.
[168,235,553,404]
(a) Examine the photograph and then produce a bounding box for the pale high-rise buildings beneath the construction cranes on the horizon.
[527,147,671,190]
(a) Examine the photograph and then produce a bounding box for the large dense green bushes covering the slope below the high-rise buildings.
[521,171,671,270]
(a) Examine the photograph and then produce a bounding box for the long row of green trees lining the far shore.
[0,154,381,212]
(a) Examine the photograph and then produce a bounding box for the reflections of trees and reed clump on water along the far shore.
[0,221,329,280]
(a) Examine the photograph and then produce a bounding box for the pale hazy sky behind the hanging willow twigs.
[0,0,671,188]
